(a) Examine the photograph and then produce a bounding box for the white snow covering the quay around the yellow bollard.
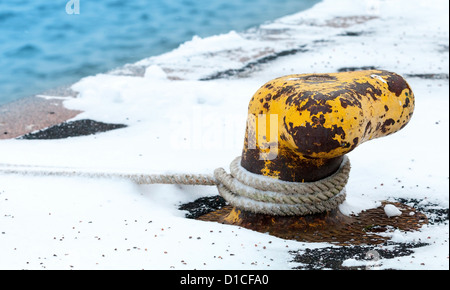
[0,0,449,269]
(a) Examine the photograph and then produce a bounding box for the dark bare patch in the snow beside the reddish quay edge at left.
[17,119,127,139]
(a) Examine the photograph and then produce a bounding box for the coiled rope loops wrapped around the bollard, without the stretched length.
[214,156,350,216]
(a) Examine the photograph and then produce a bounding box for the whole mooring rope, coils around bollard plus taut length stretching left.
[0,156,350,216]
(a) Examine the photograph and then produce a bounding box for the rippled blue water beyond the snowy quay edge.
[0,0,320,105]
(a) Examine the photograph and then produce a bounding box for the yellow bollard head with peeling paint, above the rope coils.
[241,70,414,182]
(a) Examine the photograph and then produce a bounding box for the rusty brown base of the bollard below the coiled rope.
[197,202,428,245]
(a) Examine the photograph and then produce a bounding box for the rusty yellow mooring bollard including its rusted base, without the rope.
[200,70,426,244]
